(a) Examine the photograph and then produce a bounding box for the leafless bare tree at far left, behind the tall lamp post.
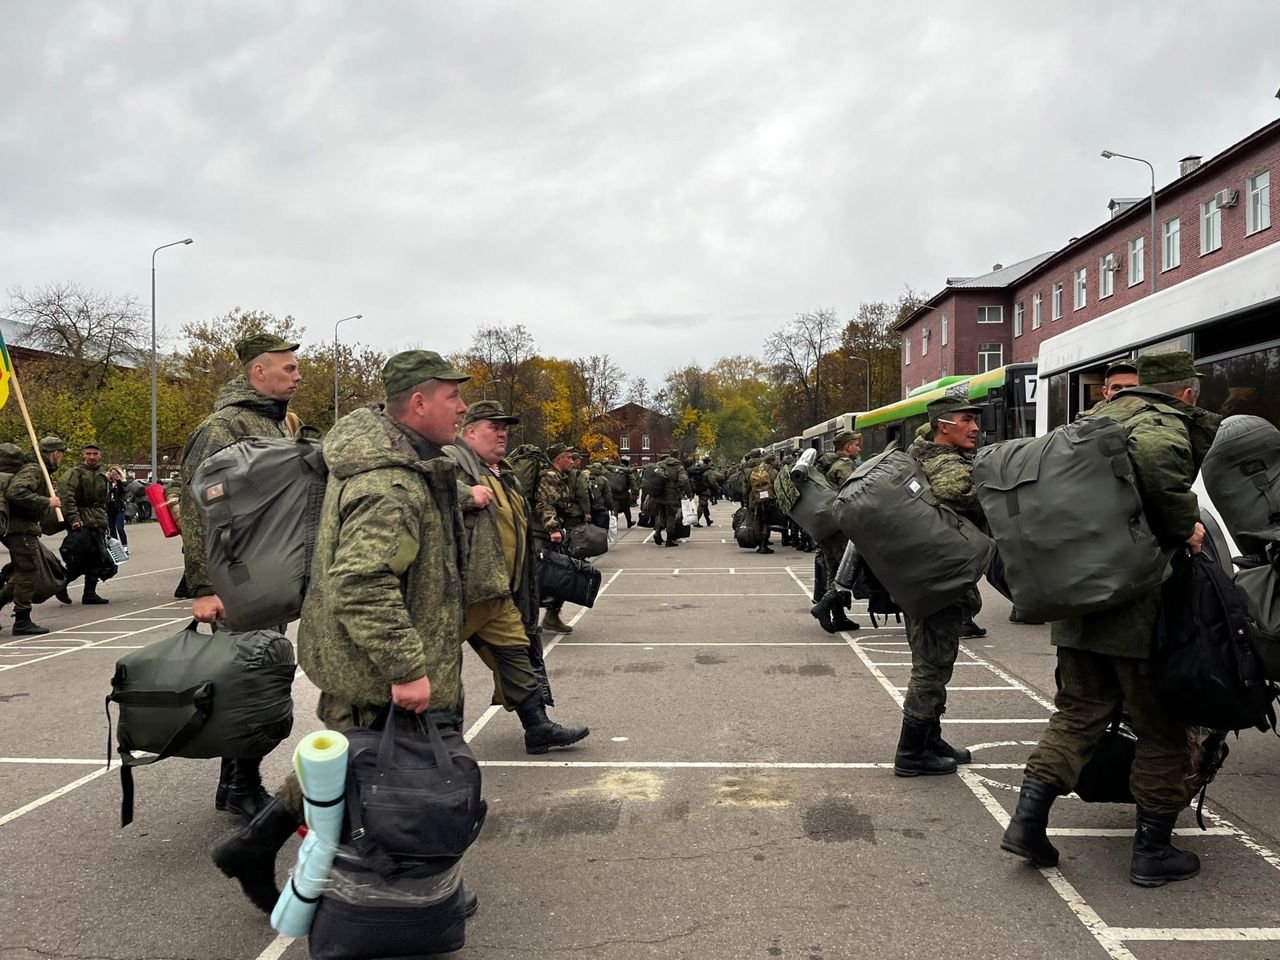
[9,283,148,390]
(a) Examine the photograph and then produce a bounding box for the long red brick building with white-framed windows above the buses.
[897,120,1280,396]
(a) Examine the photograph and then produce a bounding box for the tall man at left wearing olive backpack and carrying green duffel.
[176,333,302,819]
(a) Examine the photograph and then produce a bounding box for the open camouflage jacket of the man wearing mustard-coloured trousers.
[444,440,538,627]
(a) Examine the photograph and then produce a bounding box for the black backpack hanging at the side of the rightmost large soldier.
[1152,550,1280,731]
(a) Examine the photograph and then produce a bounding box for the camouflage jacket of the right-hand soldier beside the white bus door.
[1050,387,1222,659]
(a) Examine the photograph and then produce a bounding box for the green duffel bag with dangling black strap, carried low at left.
[106,621,298,827]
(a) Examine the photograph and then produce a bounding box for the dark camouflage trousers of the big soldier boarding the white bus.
[1027,646,1193,813]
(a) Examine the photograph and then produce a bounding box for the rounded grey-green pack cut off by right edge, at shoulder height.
[1201,416,1280,557]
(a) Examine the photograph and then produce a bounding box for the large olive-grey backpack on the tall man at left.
[192,436,328,630]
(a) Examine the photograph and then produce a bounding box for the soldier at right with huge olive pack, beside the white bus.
[1001,352,1221,887]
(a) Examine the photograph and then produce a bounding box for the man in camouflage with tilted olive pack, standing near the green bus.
[893,397,987,777]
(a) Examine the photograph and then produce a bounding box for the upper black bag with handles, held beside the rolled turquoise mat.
[342,708,486,881]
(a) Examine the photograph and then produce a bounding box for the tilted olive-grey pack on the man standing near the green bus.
[836,448,996,618]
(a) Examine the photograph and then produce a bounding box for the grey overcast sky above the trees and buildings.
[0,0,1280,381]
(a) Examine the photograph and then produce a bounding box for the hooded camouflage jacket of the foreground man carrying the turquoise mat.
[298,403,466,714]
